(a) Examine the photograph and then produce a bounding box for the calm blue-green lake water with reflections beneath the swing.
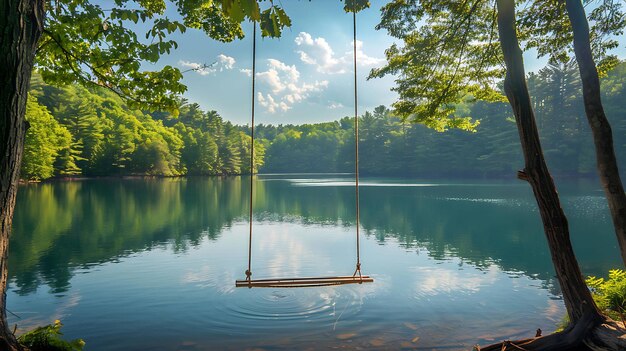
[8,175,620,350]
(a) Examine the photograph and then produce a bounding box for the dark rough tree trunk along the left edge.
[0,0,45,350]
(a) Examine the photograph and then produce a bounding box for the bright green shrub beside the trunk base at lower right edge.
[586,269,626,322]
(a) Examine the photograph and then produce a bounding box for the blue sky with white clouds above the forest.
[147,0,626,124]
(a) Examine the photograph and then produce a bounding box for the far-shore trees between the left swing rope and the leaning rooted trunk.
[258,102,520,177]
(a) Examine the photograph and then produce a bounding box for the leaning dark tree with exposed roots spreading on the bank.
[477,0,626,351]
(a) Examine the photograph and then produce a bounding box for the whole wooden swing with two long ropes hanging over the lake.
[235,12,374,288]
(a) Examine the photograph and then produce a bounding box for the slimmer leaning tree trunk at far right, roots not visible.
[565,0,626,265]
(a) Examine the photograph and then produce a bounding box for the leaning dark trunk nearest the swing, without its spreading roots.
[497,0,603,323]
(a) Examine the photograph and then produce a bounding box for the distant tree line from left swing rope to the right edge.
[256,61,626,177]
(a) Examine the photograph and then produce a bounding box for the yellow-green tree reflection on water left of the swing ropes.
[9,178,247,294]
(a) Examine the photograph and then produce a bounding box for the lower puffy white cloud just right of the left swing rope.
[256,59,328,113]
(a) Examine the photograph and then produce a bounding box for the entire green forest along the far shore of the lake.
[21,61,626,180]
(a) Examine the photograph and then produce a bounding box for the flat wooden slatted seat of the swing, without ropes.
[235,275,374,288]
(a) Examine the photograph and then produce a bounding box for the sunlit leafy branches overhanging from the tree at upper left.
[36,0,186,111]
